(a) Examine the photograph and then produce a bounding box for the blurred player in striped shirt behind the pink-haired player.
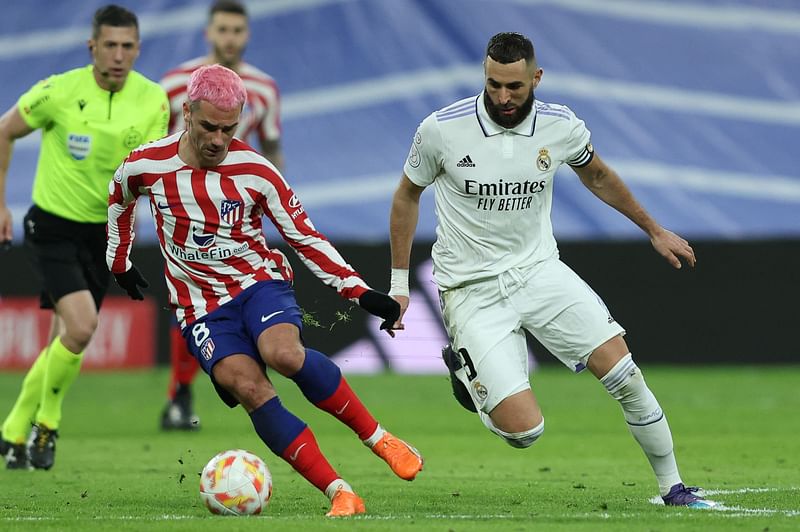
[161,0,283,430]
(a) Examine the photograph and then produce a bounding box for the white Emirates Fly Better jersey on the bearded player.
[404,92,593,290]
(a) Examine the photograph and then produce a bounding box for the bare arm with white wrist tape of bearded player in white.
[389,173,425,329]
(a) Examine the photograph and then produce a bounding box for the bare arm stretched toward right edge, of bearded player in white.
[572,154,695,268]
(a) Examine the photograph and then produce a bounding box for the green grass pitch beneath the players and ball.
[0,365,800,532]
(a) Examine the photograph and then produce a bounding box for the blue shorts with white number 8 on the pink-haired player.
[183,281,303,408]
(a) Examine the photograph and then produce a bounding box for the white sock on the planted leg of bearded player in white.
[600,353,681,495]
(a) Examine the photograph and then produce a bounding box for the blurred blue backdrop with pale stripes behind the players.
[0,0,800,370]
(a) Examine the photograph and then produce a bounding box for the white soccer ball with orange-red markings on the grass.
[200,449,272,515]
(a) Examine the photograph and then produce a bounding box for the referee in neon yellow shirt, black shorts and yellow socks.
[0,5,169,469]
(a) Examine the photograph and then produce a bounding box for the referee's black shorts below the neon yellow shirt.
[23,205,110,310]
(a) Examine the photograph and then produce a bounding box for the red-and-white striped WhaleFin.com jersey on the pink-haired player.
[106,132,369,327]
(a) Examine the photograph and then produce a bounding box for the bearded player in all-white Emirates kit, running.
[390,33,713,508]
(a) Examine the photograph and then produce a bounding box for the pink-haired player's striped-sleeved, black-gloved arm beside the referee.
[106,160,149,300]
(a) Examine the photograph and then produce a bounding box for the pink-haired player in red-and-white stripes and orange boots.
[106,65,422,517]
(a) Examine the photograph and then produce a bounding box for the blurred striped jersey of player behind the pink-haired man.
[159,57,281,142]
